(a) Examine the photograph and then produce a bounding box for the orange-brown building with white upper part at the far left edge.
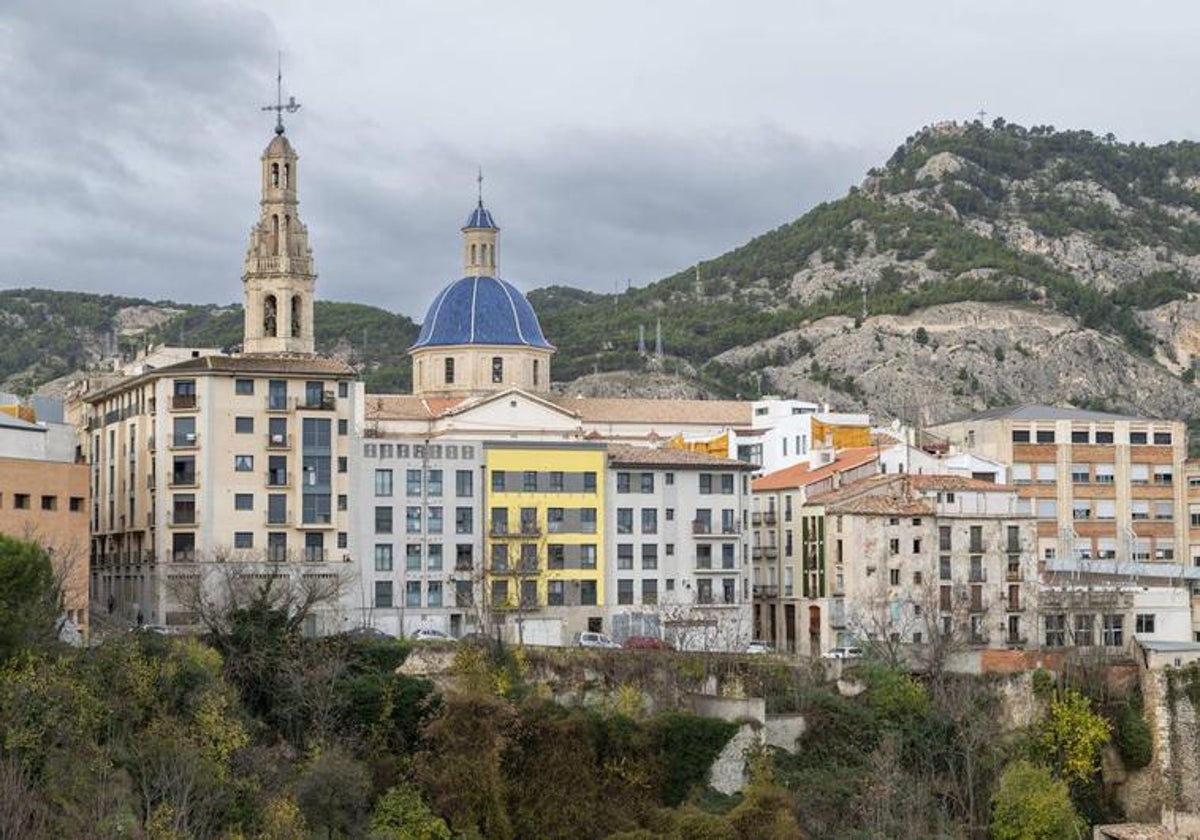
[0,412,89,638]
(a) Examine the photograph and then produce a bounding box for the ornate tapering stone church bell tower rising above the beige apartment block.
[241,122,317,353]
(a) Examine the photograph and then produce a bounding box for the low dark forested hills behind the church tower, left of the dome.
[0,289,419,394]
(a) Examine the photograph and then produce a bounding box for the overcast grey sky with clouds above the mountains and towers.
[0,0,1200,319]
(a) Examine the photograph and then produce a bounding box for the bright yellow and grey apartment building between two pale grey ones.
[484,440,608,644]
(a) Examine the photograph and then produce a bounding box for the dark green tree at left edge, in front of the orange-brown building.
[0,534,62,661]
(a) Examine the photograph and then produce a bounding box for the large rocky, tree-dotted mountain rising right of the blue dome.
[530,120,1200,421]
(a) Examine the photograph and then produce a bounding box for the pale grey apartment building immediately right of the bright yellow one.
[606,444,752,650]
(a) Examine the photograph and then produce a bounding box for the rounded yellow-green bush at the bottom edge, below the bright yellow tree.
[990,760,1086,840]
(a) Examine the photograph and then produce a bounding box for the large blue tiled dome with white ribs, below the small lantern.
[409,277,554,350]
